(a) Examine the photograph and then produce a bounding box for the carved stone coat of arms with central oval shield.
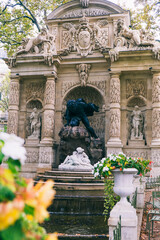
[62,16,108,57]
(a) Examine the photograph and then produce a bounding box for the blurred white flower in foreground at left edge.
[0,133,26,164]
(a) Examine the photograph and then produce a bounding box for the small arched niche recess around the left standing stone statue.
[26,99,43,137]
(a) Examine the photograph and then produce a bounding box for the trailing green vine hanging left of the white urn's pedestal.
[103,178,120,220]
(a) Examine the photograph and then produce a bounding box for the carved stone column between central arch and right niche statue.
[107,72,122,155]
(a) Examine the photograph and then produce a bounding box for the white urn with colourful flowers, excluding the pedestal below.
[93,153,152,205]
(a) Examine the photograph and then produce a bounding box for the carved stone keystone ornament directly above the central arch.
[76,63,91,87]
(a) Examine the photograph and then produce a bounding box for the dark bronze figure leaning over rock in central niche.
[65,98,99,138]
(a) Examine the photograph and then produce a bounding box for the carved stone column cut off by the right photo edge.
[151,71,160,176]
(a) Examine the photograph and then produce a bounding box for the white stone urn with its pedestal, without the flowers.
[108,168,137,240]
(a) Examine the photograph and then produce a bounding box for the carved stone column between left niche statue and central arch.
[39,72,57,169]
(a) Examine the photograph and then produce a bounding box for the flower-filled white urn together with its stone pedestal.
[93,153,152,240]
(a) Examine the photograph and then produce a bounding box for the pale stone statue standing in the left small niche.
[30,108,41,138]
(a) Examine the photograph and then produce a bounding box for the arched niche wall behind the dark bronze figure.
[62,86,105,140]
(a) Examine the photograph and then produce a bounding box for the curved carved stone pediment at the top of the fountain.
[47,0,125,20]
